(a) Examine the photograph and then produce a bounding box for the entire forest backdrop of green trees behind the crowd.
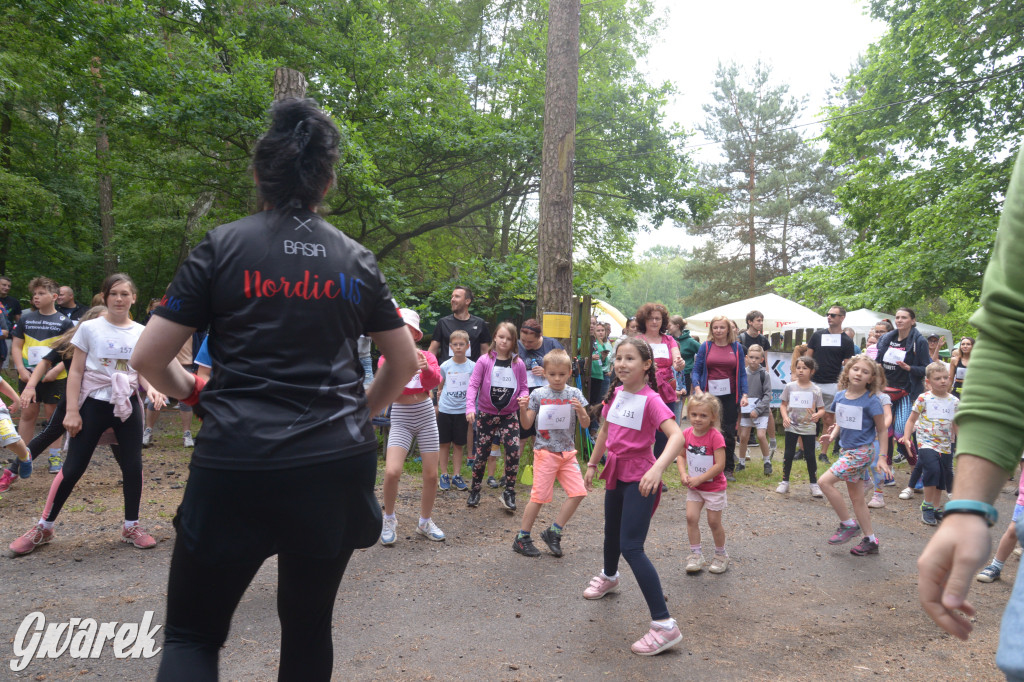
[0,0,1024,334]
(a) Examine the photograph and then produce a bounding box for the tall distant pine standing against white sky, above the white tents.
[689,61,842,304]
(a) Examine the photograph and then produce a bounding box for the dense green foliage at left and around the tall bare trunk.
[0,0,707,315]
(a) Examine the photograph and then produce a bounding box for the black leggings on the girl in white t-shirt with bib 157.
[47,395,142,521]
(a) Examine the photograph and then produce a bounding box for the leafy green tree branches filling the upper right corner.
[773,0,1024,309]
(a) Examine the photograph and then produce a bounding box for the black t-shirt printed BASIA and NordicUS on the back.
[154,209,404,470]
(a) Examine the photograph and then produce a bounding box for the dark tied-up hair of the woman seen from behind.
[252,99,341,208]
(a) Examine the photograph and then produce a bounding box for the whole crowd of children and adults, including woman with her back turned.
[0,100,1024,680]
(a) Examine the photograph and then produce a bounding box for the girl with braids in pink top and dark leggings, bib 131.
[583,338,683,656]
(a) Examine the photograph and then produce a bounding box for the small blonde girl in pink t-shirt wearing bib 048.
[676,393,729,573]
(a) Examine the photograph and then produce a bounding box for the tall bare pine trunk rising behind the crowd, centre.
[537,0,580,339]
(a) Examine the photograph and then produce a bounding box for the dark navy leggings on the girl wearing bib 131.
[604,480,669,621]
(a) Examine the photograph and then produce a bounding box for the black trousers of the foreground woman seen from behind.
[157,452,381,682]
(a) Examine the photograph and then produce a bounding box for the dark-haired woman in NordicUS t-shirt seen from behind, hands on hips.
[132,99,417,682]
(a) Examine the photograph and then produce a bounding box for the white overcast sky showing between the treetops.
[634,0,886,255]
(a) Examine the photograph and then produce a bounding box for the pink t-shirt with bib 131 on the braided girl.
[601,384,675,489]
